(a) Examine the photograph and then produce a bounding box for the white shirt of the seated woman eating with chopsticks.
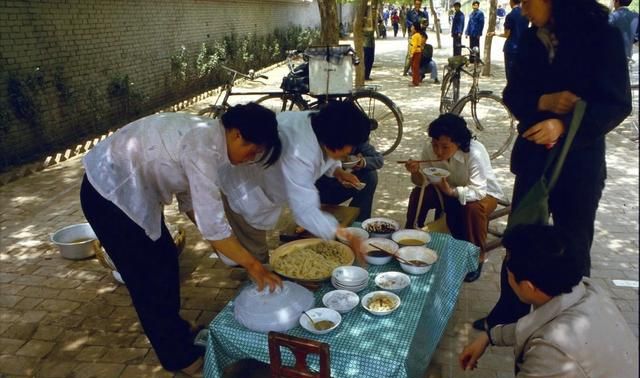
[421,139,504,205]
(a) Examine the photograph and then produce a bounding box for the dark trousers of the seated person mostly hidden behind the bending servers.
[316,169,378,222]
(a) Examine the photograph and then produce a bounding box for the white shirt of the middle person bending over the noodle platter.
[220,112,340,239]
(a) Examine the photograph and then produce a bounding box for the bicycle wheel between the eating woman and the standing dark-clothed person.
[452,93,516,160]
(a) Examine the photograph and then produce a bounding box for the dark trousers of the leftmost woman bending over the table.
[80,176,203,371]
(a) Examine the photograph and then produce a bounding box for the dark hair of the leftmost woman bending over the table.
[222,102,282,167]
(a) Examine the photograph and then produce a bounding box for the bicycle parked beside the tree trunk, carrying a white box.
[198,51,404,155]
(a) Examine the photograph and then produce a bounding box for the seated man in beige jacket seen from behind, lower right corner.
[459,225,638,378]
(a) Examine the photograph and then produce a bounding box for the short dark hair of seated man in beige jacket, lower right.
[502,224,582,297]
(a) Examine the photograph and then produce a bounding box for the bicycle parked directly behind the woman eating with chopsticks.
[440,46,516,160]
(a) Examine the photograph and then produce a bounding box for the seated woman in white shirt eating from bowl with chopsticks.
[405,113,503,282]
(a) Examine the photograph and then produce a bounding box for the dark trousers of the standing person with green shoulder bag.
[487,166,605,327]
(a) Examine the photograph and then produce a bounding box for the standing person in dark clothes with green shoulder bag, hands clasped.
[474,0,631,329]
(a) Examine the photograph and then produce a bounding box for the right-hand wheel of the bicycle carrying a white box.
[351,91,403,155]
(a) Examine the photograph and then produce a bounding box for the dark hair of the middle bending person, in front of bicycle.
[309,101,371,150]
